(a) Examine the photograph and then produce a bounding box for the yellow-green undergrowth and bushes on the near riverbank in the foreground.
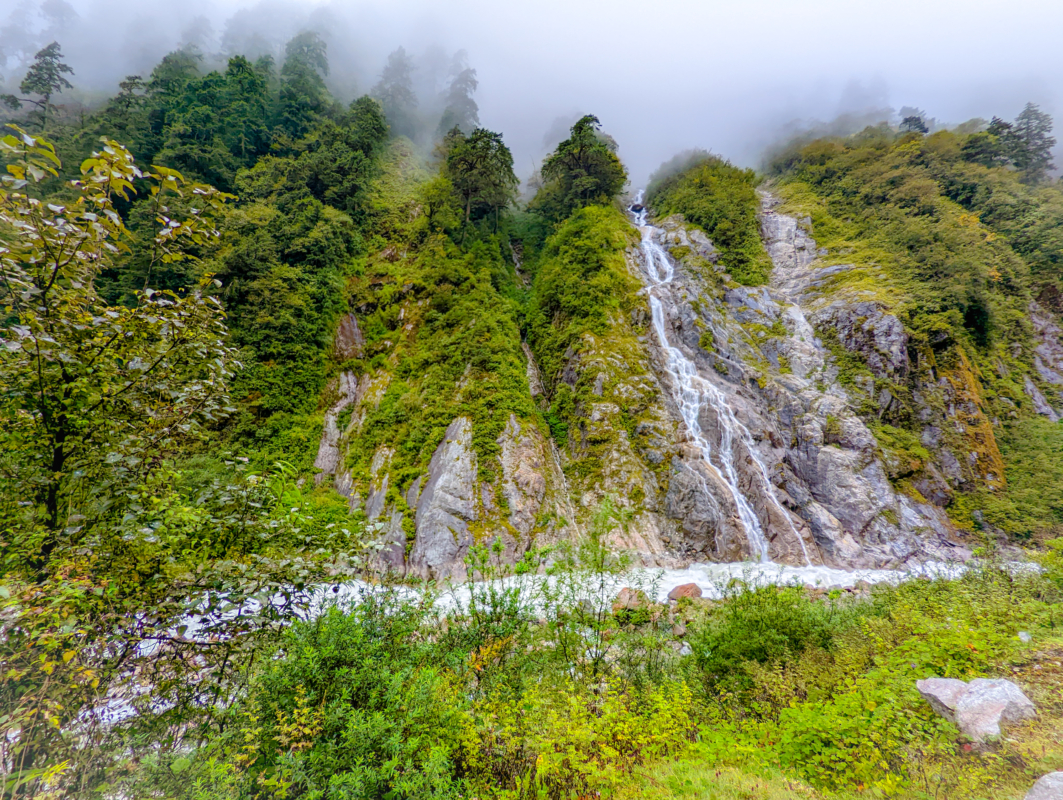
[116,531,1063,800]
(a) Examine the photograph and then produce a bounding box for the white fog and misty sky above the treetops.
[0,0,1063,185]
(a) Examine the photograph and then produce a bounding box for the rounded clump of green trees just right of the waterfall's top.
[646,153,772,286]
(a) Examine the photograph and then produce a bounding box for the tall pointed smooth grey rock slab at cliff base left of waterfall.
[407,416,477,579]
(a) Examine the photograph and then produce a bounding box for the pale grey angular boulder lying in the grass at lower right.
[915,678,1037,743]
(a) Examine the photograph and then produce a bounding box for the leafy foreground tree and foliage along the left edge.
[0,129,365,797]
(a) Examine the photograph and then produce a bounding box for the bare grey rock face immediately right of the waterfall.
[629,206,964,567]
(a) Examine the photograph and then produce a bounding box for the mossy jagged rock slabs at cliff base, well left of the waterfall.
[315,365,577,579]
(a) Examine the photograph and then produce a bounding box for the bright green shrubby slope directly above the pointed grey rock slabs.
[350,226,534,489]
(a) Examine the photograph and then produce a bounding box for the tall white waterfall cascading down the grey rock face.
[632,191,811,564]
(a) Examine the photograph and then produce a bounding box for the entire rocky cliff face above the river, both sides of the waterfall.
[316,197,982,578]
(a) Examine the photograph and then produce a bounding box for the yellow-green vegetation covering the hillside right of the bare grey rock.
[773,120,1063,537]
